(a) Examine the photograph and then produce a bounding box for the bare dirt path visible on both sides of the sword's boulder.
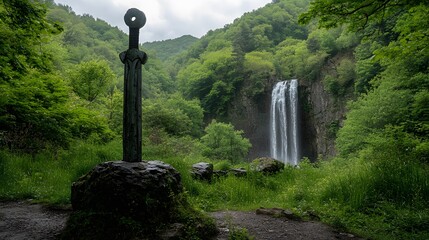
[0,202,358,240]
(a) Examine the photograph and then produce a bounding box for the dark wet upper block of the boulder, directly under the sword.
[71,161,183,223]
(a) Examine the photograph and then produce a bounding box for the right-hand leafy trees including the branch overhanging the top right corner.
[300,0,429,159]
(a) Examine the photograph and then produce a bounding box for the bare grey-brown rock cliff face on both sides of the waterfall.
[228,55,347,161]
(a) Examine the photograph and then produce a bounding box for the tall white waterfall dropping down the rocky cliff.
[270,79,300,165]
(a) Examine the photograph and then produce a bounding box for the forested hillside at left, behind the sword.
[0,1,191,153]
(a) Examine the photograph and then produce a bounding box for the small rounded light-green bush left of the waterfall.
[201,120,251,163]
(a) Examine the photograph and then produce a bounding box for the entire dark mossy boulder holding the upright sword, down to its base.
[63,161,217,239]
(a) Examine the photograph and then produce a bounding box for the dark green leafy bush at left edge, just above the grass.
[0,70,72,152]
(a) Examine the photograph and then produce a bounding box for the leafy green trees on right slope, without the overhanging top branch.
[320,2,429,158]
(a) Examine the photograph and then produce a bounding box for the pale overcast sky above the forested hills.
[55,0,271,42]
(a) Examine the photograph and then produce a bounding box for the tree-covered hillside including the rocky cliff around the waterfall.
[167,1,358,159]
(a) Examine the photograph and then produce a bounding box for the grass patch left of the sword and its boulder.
[0,142,120,204]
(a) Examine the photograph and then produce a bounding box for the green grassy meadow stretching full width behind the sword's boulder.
[0,141,429,239]
